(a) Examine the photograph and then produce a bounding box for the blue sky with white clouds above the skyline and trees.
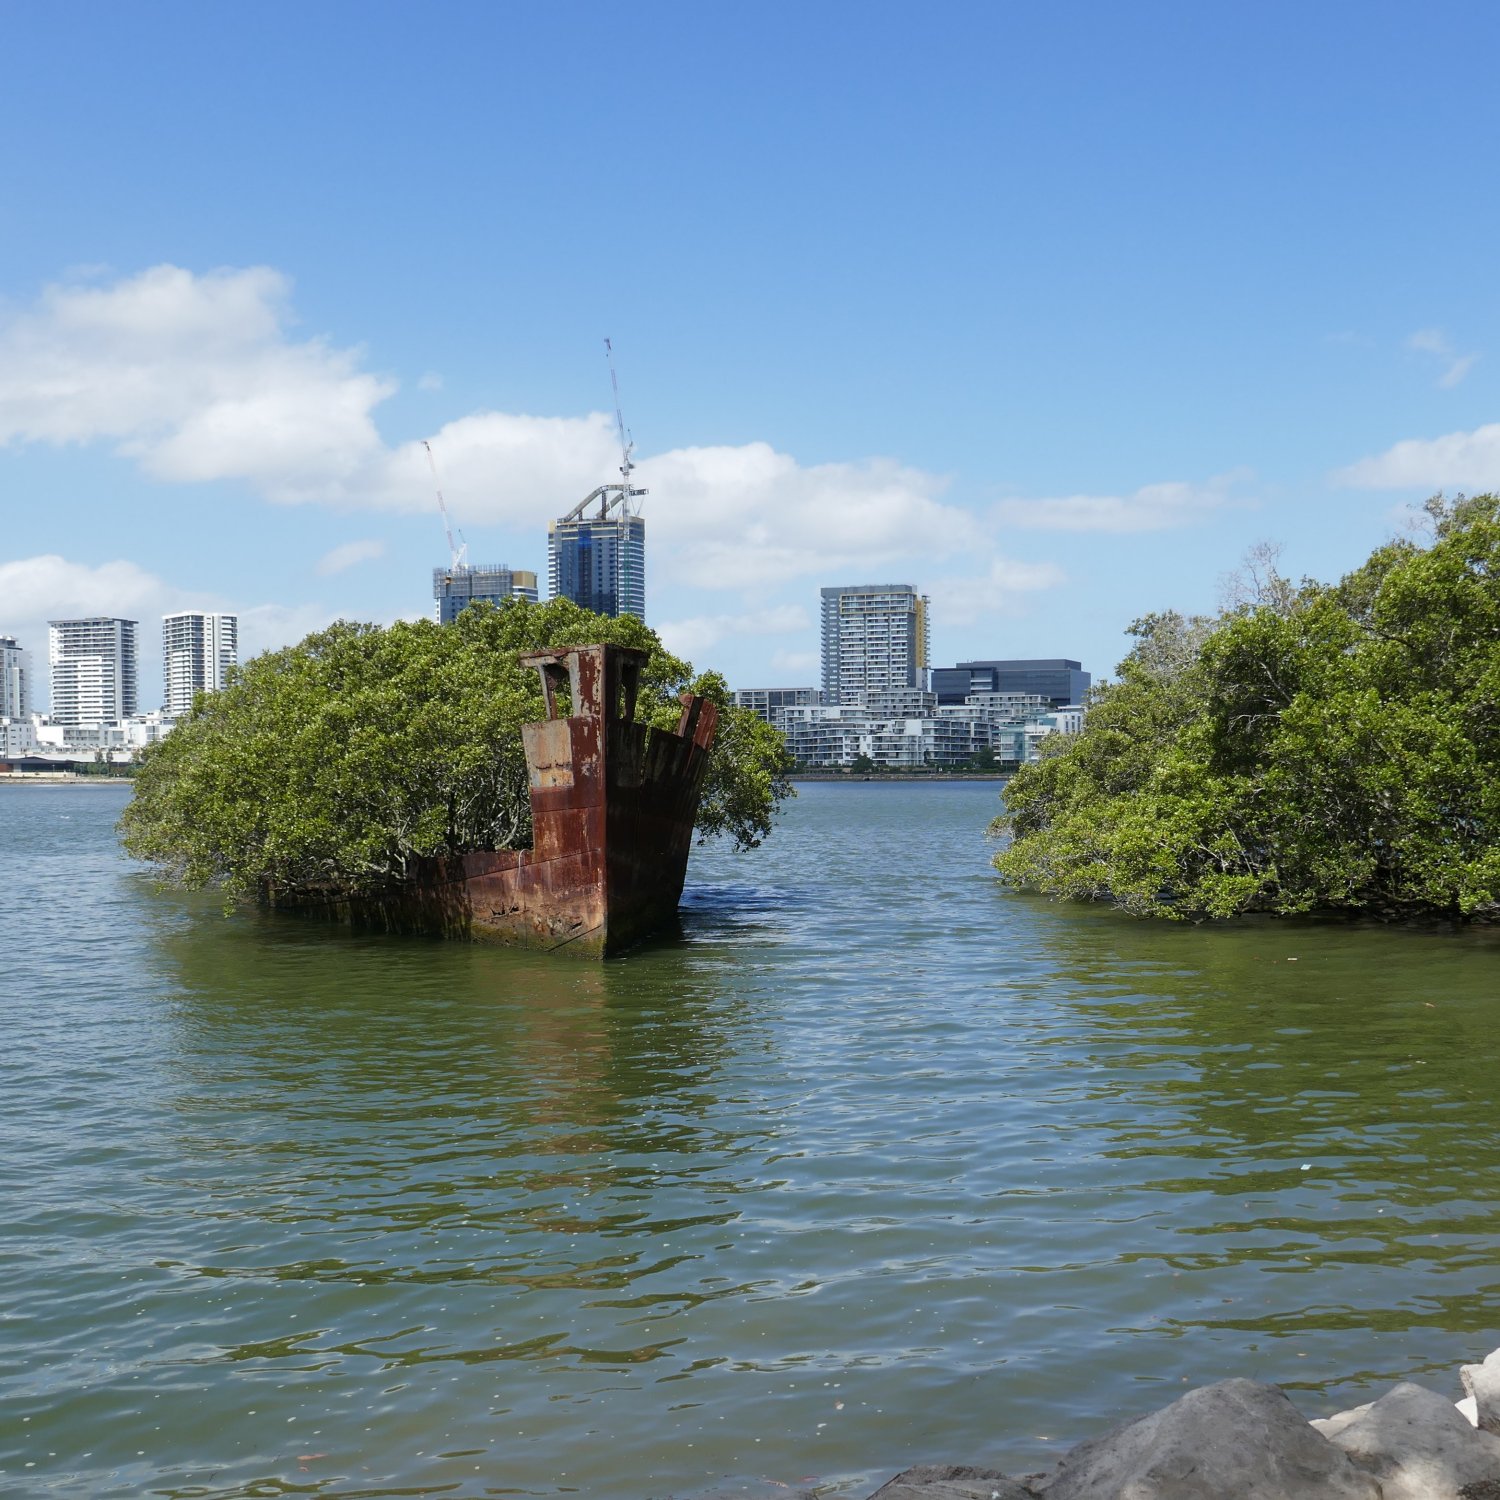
[0,0,1500,705]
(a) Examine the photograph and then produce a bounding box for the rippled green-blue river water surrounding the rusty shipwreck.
[0,783,1500,1500]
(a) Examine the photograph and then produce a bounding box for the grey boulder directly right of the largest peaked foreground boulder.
[1332,1382,1500,1500]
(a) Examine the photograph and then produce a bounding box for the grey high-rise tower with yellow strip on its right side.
[822,584,932,705]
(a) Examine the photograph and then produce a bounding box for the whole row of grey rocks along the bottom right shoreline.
[708,1349,1500,1500]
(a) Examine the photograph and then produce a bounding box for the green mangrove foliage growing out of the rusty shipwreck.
[120,600,791,902]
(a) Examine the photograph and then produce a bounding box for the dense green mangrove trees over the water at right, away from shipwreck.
[995,495,1500,921]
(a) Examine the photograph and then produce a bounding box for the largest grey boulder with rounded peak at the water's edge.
[1035,1380,1374,1500]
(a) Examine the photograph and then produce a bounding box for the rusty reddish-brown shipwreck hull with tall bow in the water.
[300,645,719,957]
